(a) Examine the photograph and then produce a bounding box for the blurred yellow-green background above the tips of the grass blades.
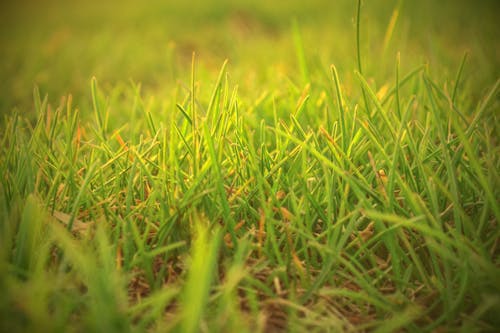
[0,0,500,113]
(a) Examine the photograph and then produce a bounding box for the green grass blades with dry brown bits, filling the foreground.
[0,0,500,332]
